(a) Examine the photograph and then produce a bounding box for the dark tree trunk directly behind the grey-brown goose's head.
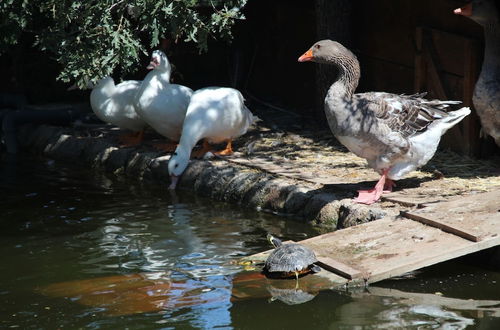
[314,0,352,123]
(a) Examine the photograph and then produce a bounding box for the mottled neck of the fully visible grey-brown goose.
[327,54,361,101]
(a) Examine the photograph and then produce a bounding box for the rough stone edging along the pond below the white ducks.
[18,125,398,230]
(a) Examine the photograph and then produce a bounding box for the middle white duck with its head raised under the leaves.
[136,50,193,151]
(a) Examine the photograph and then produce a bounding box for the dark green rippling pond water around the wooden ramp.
[0,156,500,329]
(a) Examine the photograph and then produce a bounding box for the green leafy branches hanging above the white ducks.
[0,0,246,87]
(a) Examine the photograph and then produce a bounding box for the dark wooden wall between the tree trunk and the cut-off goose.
[346,0,490,155]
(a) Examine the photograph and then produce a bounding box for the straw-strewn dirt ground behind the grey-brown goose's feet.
[227,102,500,203]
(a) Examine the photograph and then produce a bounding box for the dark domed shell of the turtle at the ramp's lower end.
[264,244,318,276]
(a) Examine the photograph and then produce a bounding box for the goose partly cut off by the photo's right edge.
[454,0,500,146]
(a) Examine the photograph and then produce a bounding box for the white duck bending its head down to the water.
[168,87,254,189]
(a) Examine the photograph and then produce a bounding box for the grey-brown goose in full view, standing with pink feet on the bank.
[299,40,470,204]
